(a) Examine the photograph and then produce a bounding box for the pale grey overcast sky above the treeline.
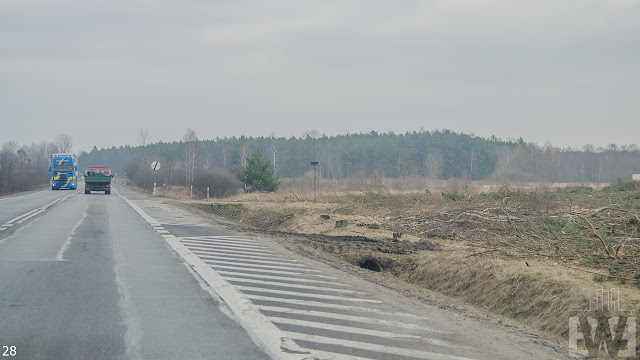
[0,0,640,150]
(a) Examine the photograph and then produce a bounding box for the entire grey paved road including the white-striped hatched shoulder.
[0,185,562,360]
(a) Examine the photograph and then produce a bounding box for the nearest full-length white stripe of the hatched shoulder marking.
[286,331,472,360]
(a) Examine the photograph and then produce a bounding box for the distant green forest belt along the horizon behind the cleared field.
[79,130,640,185]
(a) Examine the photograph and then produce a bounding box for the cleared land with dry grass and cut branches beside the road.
[126,182,640,348]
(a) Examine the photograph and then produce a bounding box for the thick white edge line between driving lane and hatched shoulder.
[114,189,317,360]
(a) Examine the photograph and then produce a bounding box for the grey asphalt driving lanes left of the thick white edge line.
[0,186,268,359]
